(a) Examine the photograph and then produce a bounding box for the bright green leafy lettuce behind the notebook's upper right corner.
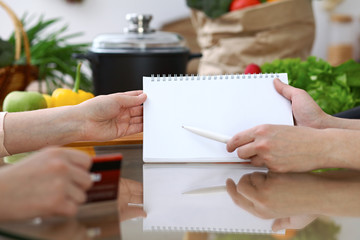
[261,56,360,114]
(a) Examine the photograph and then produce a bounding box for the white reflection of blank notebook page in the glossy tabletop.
[143,163,284,234]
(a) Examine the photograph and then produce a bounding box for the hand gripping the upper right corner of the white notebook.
[274,78,330,128]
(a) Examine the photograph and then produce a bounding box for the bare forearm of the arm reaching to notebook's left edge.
[4,106,81,154]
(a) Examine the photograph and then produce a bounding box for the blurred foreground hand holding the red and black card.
[0,148,92,221]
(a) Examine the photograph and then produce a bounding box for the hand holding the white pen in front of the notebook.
[227,125,332,172]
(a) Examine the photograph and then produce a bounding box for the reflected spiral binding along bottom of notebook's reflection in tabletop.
[145,226,274,234]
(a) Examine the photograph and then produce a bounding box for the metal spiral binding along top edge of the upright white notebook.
[151,73,280,82]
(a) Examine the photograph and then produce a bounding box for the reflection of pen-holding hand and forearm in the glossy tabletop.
[226,171,360,231]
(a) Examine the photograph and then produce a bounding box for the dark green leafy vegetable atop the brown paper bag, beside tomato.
[186,0,232,18]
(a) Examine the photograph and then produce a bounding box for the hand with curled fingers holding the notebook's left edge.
[75,91,146,141]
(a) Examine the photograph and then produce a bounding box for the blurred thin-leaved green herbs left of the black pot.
[9,14,92,94]
